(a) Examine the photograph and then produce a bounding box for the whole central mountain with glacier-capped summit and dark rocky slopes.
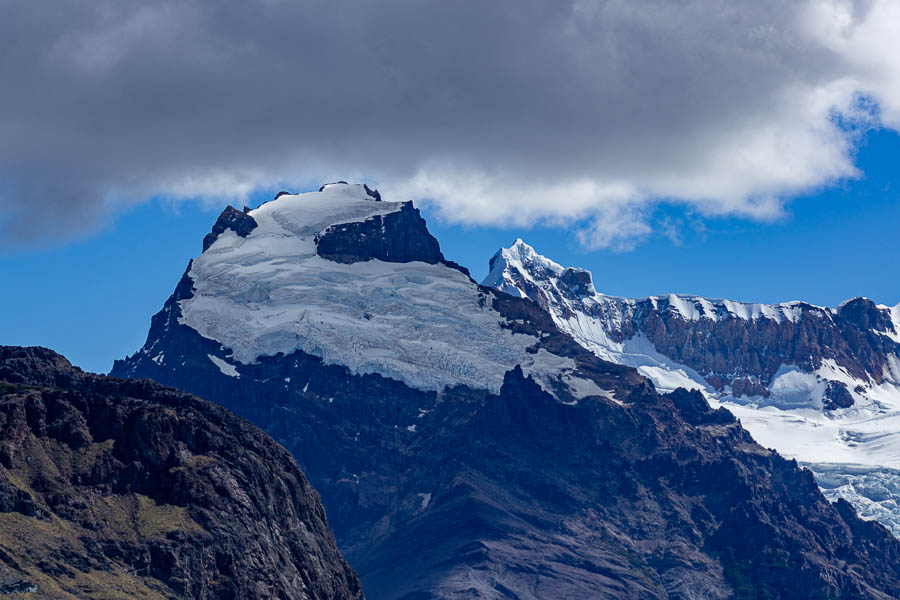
[113,184,900,600]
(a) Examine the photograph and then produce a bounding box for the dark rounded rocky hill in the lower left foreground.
[0,347,362,600]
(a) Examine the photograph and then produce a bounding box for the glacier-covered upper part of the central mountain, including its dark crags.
[117,182,624,402]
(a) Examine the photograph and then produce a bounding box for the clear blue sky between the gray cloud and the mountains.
[0,131,900,372]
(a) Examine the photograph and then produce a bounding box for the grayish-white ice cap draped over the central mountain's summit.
[180,184,590,397]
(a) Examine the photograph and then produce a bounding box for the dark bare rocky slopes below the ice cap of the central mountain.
[114,274,900,600]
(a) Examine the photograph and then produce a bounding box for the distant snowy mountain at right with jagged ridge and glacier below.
[483,240,900,533]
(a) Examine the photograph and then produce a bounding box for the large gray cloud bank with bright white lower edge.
[0,0,900,247]
